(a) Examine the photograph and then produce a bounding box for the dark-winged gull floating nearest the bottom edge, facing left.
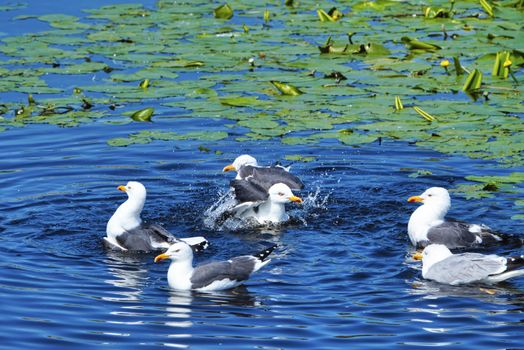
[155,242,276,292]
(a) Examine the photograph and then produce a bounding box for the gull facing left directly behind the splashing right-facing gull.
[223,154,304,191]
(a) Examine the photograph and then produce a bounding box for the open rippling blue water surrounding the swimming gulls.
[0,1,524,349]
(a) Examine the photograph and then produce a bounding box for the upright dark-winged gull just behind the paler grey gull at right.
[408,187,502,249]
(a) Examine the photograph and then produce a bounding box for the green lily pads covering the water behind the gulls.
[0,0,524,216]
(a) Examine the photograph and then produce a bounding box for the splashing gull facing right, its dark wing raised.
[230,179,303,224]
